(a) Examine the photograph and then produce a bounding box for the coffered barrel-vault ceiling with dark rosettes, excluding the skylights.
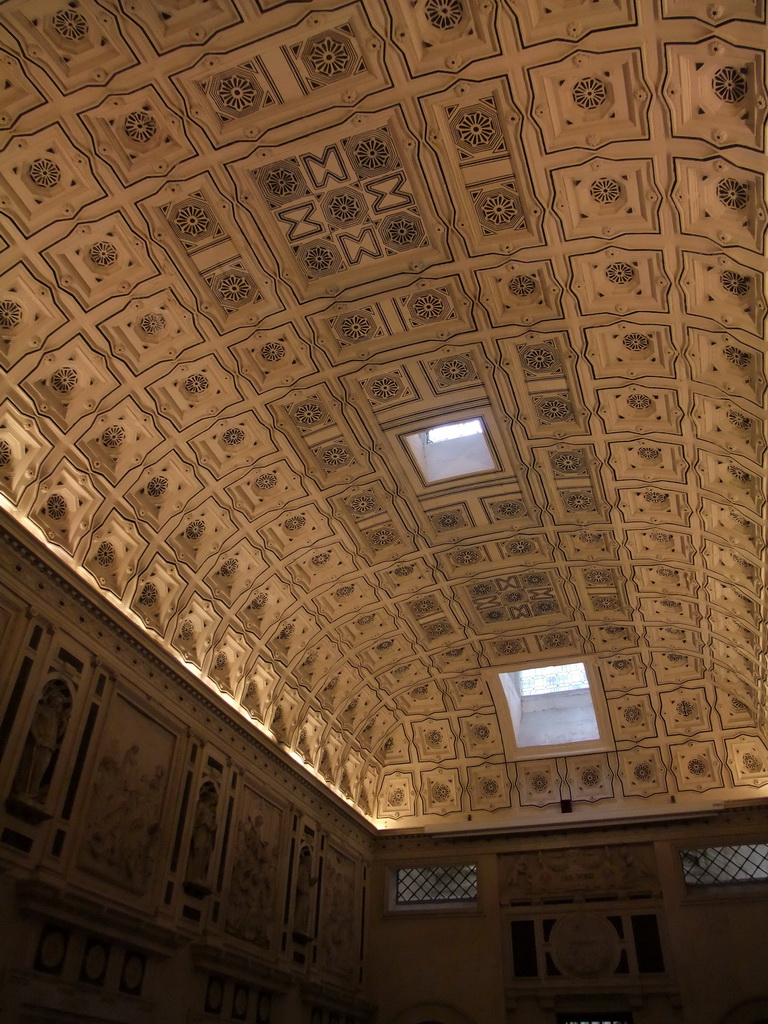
[0,0,768,827]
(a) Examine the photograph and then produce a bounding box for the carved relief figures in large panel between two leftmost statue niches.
[85,743,165,894]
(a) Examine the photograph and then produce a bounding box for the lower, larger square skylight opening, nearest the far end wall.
[499,662,600,746]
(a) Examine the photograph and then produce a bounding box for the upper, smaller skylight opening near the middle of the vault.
[403,418,497,483]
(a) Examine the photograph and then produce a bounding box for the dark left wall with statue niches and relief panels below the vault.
[0,536,372,1024]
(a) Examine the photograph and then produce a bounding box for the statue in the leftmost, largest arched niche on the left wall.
[7,679,72,821]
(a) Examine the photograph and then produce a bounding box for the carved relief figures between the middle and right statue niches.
[226,814,275,947]
